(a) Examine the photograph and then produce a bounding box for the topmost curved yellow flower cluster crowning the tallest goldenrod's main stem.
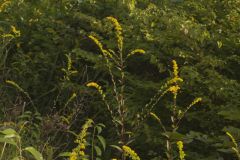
[107,17,123,51]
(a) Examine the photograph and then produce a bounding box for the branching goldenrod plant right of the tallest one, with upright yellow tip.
[145,60,202,160]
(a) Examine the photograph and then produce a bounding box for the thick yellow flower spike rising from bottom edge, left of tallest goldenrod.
[69,119,93,160]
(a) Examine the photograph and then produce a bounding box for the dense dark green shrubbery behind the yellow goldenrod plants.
[0,0,240,160]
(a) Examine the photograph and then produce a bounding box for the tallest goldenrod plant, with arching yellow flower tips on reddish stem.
[87,17,145,159]
